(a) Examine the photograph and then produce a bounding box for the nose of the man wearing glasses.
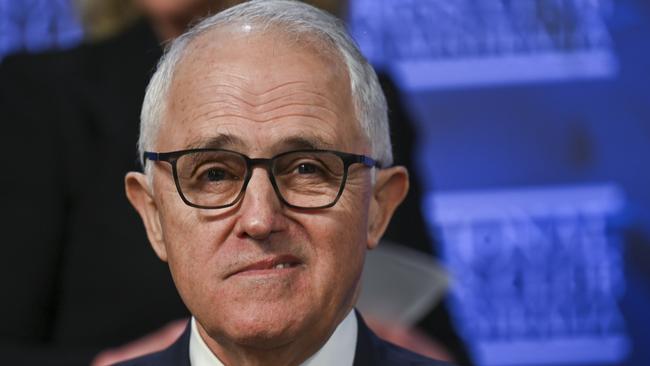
[236,168,282,240]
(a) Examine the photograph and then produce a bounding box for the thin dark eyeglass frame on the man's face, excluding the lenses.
[142,148,381,210]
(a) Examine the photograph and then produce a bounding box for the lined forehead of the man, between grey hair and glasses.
[159,27,360,154]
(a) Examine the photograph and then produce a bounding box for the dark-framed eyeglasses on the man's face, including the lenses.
[144,149,380,209]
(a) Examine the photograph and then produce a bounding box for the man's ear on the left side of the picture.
[124,172,167,262]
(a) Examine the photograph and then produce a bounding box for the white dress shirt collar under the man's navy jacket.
[190,310,357,366]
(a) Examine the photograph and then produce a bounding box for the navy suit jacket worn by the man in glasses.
[118,313,451,366]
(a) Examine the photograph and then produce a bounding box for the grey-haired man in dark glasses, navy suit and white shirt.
[120,0,450,366]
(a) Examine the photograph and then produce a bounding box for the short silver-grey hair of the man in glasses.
[138,0,393,176]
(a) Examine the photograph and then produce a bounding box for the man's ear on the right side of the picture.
[368,166,409,249]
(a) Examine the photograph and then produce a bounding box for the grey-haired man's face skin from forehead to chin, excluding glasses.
[147,30,372,348]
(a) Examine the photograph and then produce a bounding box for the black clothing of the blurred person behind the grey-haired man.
[0,17,467,365]
